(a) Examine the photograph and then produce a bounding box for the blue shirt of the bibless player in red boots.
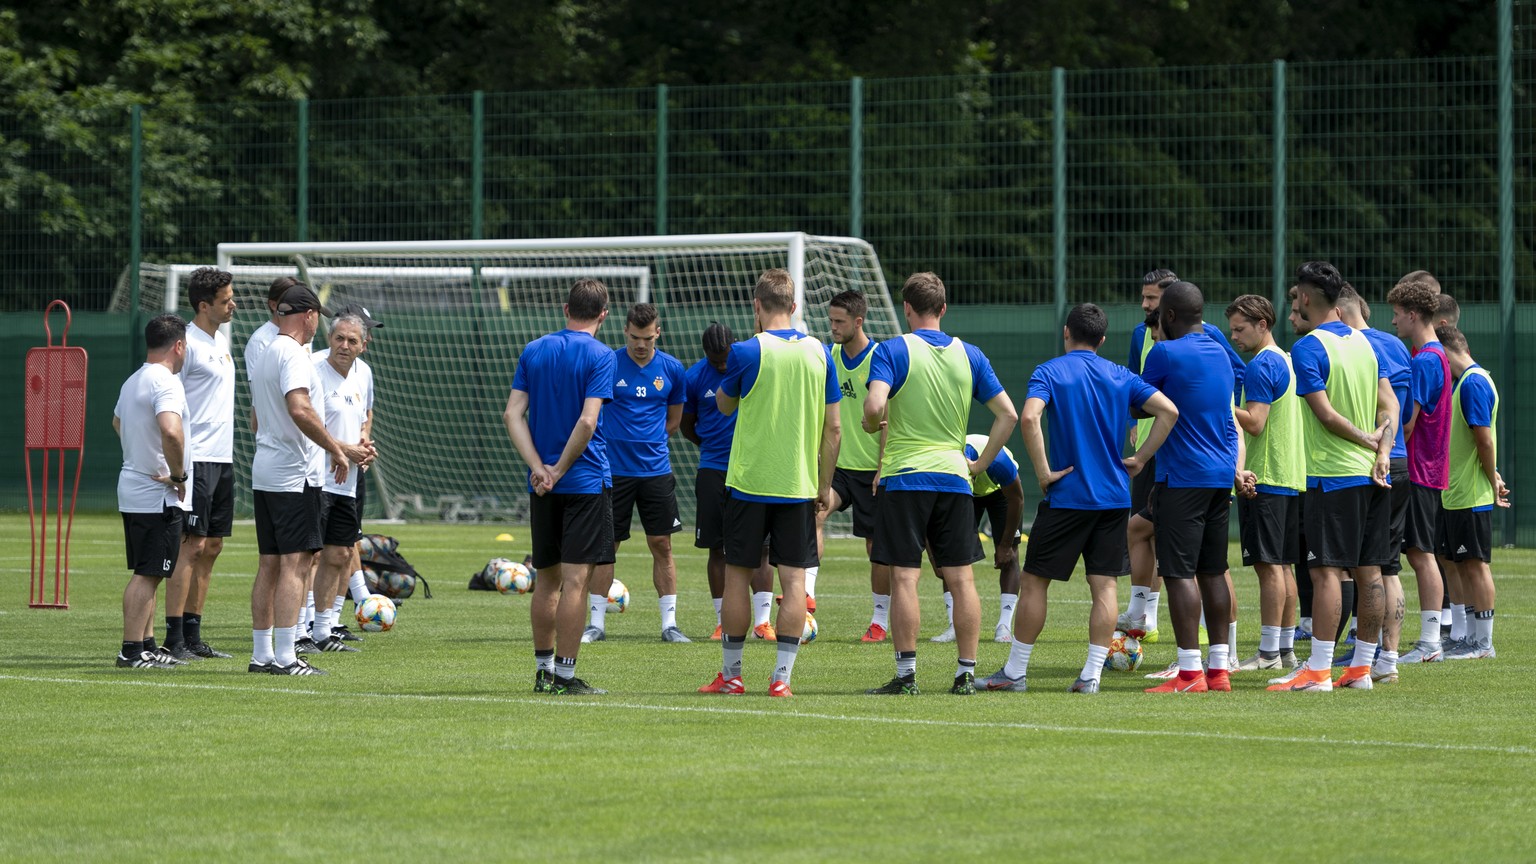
[1127,332,1238,488]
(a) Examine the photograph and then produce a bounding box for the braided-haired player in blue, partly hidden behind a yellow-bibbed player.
[679,321,777,641]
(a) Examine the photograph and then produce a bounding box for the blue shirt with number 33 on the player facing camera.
[602,347,688,477]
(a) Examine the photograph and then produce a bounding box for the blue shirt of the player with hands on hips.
[1026,351,1155,510]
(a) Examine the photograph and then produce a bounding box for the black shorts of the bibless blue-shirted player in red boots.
[1155,483,1232,580]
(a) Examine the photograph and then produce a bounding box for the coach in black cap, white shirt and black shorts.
[247,283,373,675]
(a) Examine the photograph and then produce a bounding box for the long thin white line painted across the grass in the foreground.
[0,675,1536,756]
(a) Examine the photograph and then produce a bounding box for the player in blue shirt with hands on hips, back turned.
[977,303,1178,693]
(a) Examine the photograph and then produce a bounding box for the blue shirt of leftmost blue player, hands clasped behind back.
[511,331,616,495]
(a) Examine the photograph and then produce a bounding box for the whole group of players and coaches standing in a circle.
[115,261,1508,696]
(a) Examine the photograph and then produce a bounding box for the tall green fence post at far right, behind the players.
[1498,0,1518,546]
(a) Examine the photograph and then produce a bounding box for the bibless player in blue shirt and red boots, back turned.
[1141,281,1238,693]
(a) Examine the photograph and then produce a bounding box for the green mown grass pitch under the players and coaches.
[0,515,1536,862]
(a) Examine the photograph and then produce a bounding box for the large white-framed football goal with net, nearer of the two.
[135,234,900,530]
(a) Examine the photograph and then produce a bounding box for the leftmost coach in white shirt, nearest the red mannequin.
[112,315,192,669]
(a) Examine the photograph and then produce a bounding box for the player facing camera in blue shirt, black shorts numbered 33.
[581,303,691,643]
